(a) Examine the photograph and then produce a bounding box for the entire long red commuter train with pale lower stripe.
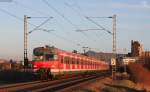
[32,46,109,76]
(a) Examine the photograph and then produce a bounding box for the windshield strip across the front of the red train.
[34,54,58,61]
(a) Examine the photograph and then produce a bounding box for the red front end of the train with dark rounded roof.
[32,47,59,77]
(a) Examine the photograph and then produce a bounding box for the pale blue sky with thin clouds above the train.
[0,0,150,60]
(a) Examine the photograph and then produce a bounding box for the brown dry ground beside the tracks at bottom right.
[67,77,150,92]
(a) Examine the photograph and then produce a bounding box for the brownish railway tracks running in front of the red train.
[0,74,110,92]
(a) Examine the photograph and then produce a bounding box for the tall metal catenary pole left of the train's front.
[24,15,30,68]
